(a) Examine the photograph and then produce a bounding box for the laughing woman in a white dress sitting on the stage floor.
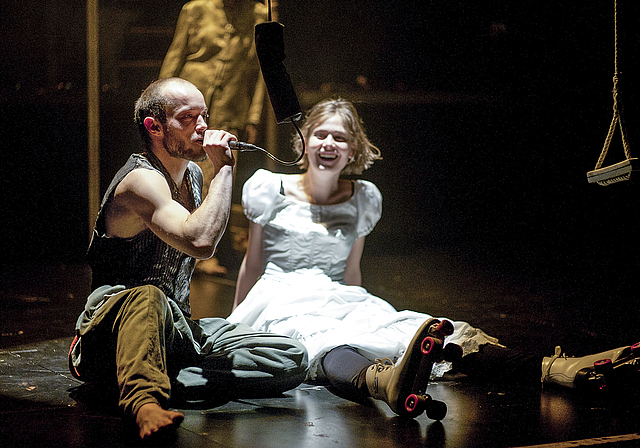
[228,100,636,413]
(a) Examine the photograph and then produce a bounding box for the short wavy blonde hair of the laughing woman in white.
[293,99,382,175]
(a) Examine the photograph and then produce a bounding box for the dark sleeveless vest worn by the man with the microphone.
[87,154,202,316]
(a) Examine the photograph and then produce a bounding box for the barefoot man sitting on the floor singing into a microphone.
[69,78,308,438]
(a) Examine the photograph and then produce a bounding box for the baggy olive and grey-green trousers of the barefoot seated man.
[69,285,308,416]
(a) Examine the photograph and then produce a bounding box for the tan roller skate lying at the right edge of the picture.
[542,342,640,393]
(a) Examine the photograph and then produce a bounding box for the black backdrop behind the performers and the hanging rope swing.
[0,0,640,315]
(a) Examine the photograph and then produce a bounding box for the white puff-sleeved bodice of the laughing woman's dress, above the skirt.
[242,170,382,282]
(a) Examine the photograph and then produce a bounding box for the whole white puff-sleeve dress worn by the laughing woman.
[228,170,497,380]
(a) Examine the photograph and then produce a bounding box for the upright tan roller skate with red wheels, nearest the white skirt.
[366,319,462,420]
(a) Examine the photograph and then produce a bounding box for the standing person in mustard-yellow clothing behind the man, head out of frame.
[159,0,267,274]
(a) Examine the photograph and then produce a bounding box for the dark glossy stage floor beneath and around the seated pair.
[0,249,640,448]
